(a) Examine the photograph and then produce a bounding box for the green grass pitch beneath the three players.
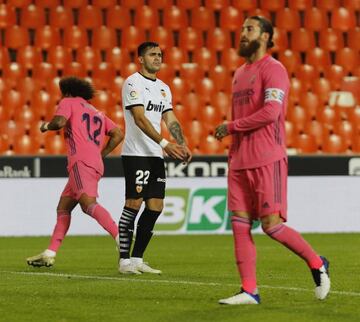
[0,234,360,322]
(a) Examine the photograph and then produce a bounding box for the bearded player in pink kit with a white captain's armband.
[215,16,330,305]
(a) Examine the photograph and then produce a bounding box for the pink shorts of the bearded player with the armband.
[228,159,288,221]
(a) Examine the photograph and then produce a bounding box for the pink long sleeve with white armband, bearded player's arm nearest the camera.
[227,64,289,134]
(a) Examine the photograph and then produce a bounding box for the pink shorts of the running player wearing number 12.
[61,161,101,200]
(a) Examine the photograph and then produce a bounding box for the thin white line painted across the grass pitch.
[0,271,360,296]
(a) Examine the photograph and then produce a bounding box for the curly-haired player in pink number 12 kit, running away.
[27,77,123,267]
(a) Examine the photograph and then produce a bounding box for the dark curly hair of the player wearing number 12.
[59,76,95,100]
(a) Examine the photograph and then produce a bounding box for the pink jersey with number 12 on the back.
[55,97,116,175]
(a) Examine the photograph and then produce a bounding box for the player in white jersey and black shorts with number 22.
[119,42,191,274]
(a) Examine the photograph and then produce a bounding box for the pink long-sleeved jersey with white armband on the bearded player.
[228,55,290,169]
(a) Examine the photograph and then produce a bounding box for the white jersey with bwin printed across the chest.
[122,72,172,158]
